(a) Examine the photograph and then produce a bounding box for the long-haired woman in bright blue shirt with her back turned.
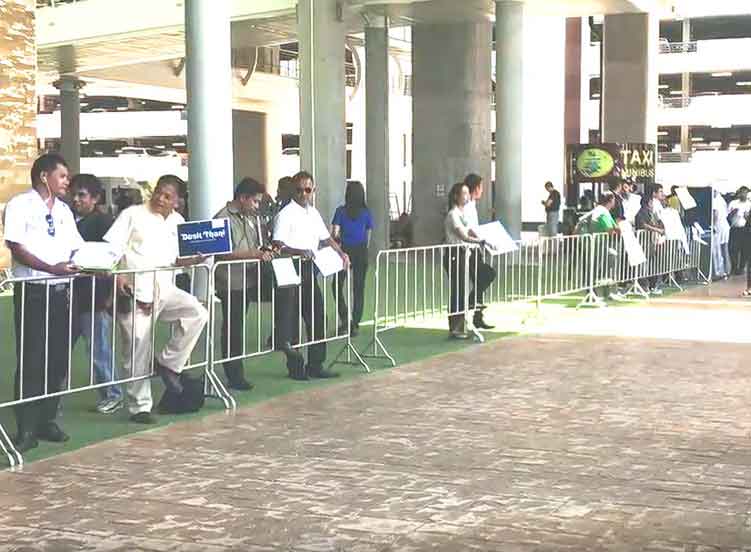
[331,180,373,335]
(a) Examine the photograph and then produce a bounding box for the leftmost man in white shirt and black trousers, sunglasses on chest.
[4,153,83,452]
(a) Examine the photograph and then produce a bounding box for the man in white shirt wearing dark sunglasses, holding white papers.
[273,171,349,380]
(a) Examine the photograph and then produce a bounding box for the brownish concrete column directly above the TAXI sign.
[602,13,660,144]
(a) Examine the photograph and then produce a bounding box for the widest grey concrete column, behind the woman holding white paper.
[412,21,492,245]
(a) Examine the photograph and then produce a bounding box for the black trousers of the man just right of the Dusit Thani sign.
[216,288,258,382]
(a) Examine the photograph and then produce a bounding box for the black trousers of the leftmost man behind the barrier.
[13,284,71,433]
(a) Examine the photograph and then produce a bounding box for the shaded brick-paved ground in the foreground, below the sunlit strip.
[0,330,751,552]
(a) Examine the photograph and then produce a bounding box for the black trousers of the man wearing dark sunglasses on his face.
[274,260,326,369]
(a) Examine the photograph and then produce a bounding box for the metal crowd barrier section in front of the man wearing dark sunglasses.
[209,259,370,408]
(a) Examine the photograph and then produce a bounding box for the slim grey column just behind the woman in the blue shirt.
[365,17,389,257]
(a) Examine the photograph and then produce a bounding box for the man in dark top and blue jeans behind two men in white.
[71,174,123,414]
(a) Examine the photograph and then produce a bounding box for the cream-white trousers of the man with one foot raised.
[117,285,209,414]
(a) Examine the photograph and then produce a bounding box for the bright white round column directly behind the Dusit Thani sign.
[185,0,234,220]
